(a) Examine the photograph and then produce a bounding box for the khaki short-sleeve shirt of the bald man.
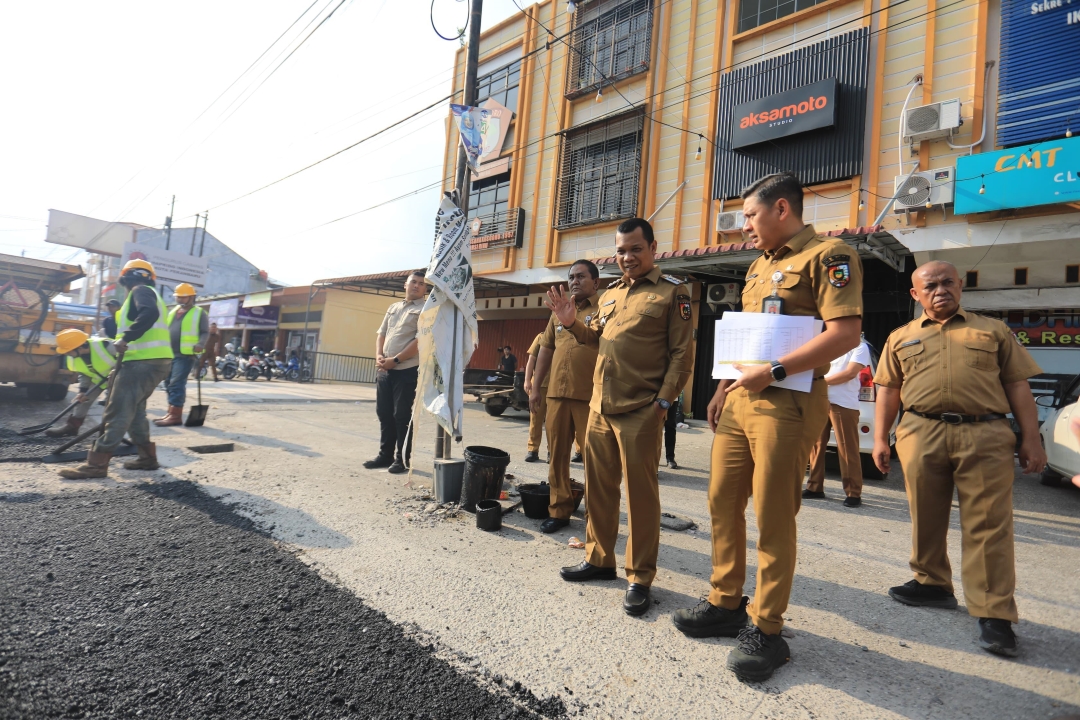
[874,308,1041,415]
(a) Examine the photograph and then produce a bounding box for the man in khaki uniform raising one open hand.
[548,218,693,615]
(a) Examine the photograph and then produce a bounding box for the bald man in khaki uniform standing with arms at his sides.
[874,261,1047,656]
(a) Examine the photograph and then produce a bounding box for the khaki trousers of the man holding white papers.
[708,380,828,635]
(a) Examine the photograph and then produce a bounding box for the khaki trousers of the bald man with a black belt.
[896,412,1018,623]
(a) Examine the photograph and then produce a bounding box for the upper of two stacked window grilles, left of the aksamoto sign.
[566,0,652,97]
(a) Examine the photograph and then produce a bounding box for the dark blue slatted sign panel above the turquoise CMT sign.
[997,0,1080,147]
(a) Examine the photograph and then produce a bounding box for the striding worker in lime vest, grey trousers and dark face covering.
[60,259,173,480]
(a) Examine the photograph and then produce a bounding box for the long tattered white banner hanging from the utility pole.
[417,196,477,440]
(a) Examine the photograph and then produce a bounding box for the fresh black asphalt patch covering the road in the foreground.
[0,481,566,720]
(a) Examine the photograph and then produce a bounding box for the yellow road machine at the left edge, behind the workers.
[0,255,94,400]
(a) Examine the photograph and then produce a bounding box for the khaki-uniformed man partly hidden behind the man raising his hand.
[529,260,600,532]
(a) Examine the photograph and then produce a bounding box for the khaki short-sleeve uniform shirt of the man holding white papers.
[742,225,863,376]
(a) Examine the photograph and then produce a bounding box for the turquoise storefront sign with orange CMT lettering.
[954,137,1080,215]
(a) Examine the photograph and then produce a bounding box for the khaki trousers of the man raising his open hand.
[584,403,664,585]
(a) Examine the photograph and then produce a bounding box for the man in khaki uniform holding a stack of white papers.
[672,173,863,681]
